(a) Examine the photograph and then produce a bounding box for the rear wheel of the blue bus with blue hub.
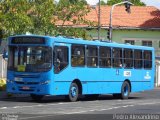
[121,81,131,99]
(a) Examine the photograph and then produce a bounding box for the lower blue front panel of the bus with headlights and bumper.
[7,70,54,95]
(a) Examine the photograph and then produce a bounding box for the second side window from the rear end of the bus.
[134,50,143,69]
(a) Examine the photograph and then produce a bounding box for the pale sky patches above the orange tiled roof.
[86,0,160,9]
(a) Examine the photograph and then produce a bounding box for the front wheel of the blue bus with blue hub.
[68,83,79,102]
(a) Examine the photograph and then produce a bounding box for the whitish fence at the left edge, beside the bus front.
[0,54,7,78]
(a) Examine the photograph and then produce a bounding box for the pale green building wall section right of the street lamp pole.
[113,30,160,56]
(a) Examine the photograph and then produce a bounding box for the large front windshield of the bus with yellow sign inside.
[8,46,52,72]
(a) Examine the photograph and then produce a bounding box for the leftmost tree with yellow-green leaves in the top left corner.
[0,0,32,37]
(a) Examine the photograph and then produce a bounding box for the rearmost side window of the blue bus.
[143,50,152,69]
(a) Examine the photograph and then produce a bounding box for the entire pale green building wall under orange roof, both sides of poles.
[88,29,160,56]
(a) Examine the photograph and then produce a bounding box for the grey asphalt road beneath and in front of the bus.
[0,88,160,120]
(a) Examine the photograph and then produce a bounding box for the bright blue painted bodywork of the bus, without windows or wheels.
[7,35,155,95]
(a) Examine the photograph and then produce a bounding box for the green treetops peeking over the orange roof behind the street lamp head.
[107,0,145,6]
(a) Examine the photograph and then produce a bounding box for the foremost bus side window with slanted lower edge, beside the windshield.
[54,46,68,73]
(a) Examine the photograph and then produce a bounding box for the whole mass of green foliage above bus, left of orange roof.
[0,0,92,39]
